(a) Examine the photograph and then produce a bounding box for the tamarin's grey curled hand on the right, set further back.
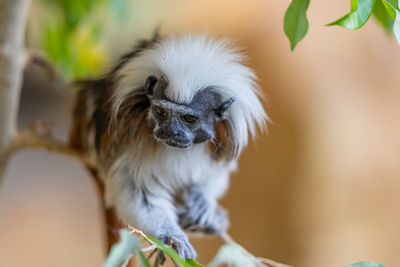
[179,191,229,235]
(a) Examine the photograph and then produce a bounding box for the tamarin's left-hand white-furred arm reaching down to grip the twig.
[106,177,196,259]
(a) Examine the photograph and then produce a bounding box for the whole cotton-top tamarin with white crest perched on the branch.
[71,35,267,259]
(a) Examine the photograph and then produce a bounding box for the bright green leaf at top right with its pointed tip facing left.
[327,0,375,30]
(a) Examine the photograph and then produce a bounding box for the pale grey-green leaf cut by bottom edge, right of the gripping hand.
[207,244,257,267]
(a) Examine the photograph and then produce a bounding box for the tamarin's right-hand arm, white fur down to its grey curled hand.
[179,175,229,234]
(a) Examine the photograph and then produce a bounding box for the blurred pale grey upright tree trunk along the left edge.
[0,0,30,186]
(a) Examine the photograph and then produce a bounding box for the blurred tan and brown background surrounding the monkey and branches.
[0,0,400,267]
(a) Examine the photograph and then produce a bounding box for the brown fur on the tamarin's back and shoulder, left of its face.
[70,76,159,171]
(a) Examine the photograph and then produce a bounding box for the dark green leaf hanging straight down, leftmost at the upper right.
[283,0,310,51]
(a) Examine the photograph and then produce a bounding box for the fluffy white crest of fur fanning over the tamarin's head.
[113,35,268,154]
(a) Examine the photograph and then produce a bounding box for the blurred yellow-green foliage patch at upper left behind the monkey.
[41,0,130,79]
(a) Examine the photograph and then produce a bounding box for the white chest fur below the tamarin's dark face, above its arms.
[105,144,237,208]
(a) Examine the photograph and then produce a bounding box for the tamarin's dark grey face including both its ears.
[145,76,233,148]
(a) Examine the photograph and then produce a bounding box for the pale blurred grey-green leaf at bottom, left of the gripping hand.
[103,229,141,267]
